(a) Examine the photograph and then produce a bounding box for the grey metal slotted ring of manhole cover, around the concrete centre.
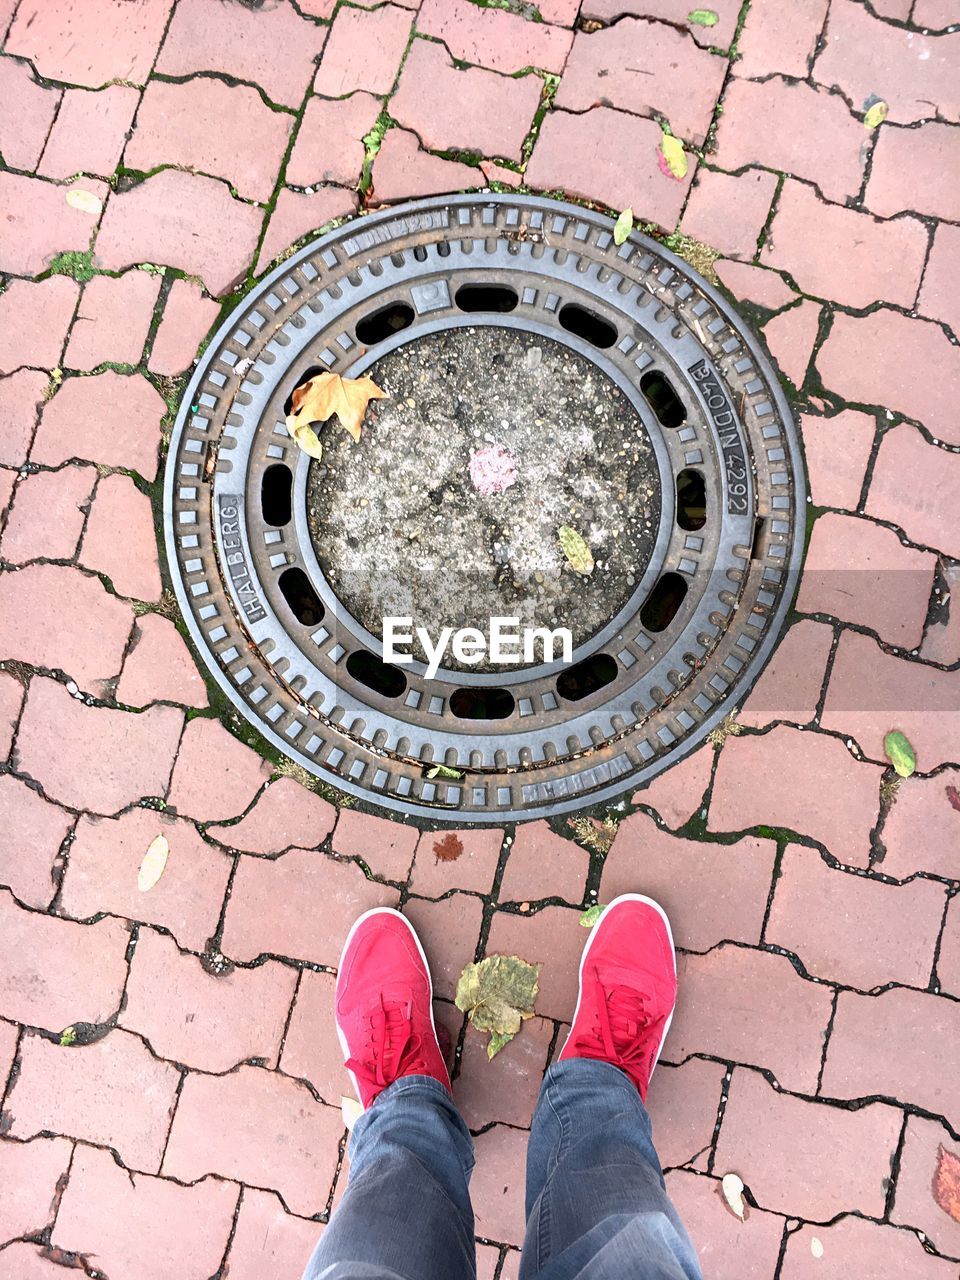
[164,196,805,823]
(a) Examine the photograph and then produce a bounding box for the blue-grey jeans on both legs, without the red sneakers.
[303,1059,703,1280]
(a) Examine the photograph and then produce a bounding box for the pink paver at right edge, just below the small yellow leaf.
[864,120,960,221]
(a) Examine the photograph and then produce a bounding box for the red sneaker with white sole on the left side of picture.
[335,906,451,1108]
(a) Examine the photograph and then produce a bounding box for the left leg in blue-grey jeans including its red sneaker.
[303,909,476,1280]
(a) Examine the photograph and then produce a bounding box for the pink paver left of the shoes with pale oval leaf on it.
[61,803,230,951]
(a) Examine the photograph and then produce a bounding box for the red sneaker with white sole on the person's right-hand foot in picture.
[558,893,677,1101]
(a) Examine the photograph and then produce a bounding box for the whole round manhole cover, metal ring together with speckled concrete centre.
[164,195,805,823]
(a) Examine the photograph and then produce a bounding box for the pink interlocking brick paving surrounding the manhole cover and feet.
[0,0,960,1280]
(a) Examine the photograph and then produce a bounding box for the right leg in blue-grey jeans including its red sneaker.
[520,895,701,1280]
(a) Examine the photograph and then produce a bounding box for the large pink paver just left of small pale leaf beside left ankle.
[164,1066,343,1216]
